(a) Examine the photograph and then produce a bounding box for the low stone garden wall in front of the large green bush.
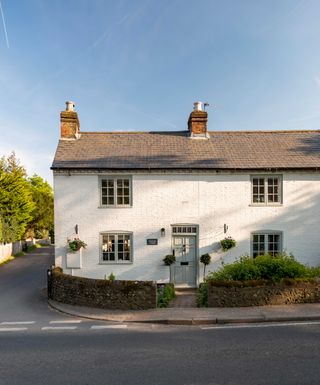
[208,280,320,307]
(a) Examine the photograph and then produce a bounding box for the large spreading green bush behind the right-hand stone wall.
[207,253,320,282]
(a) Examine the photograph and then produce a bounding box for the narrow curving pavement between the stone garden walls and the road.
[49,300,320,325]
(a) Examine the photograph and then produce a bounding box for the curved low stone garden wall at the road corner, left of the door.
[48,268,157,310]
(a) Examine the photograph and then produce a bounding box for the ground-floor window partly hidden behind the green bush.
[251,231,282,257]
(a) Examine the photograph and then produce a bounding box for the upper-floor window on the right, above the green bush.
[251,175,282,205]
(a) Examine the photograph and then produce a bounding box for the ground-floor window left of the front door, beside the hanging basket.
[101,233,132,263]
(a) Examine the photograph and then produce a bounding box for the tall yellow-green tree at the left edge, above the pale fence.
[0,153,35,243]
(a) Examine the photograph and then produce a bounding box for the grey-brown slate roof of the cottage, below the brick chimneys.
[52,130,320,170]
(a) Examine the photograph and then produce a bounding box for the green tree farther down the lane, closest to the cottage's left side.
[27,174,54,238]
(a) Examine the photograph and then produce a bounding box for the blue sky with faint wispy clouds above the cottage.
[0,0,320,183]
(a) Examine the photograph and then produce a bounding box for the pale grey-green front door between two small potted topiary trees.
[172,235,197,287]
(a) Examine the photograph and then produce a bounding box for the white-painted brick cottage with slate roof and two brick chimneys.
[52,102,320,287]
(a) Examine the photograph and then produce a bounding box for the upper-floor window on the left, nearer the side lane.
[100,176,132,207]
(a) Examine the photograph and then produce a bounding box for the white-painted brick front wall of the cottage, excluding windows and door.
[54,173,320,282]
